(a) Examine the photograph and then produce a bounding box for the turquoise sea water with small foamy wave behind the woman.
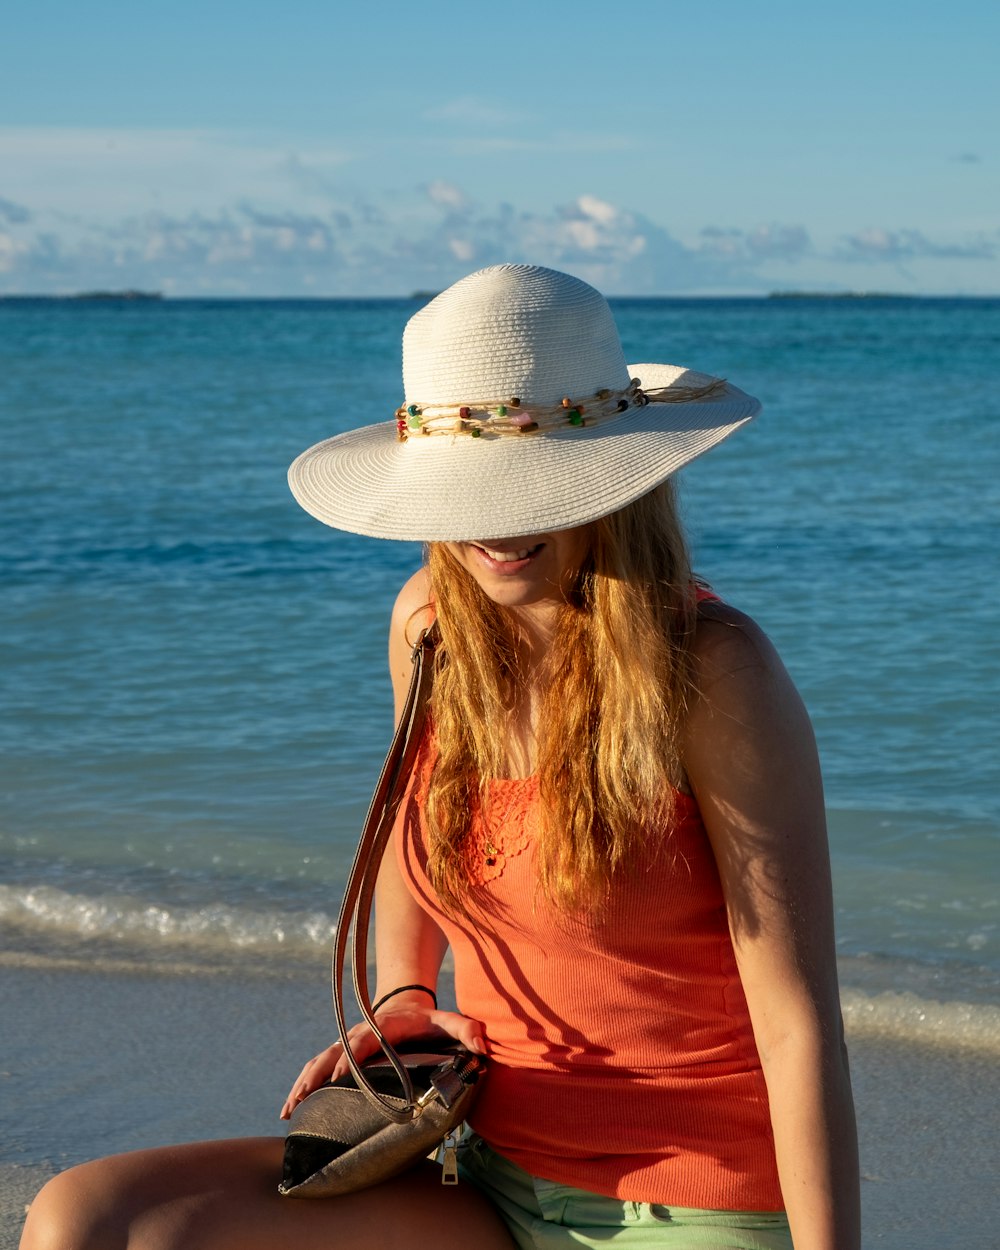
[0,300,1000,1000]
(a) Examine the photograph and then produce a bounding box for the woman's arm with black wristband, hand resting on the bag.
[281,570,486,1119]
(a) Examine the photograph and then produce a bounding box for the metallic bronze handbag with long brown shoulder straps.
[278,626,486,1198]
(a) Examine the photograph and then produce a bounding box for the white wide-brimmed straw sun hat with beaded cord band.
[289,265,760,543]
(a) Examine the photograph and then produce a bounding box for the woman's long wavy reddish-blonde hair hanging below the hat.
[426,481,696,913]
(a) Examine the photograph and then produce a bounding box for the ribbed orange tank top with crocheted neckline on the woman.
[395,743,784,1210]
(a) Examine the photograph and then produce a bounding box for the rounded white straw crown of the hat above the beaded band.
[403,265,629,404]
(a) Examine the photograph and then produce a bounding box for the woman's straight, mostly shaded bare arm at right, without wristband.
[684,605,861,1250]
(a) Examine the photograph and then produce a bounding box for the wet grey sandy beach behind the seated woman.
[0,960,1000,1250]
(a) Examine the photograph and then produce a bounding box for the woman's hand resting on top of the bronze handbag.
[281,994,486,1120]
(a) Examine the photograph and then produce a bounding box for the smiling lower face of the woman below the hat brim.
[445,525,590,620]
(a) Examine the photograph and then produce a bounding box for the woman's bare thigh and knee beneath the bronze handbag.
[21,1138,513,1250]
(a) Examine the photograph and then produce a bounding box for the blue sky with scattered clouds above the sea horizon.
[0,0,1000,295]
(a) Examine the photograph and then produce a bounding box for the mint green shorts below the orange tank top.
[459,1134,791,1250]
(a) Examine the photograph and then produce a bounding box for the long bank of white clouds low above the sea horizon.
[0,179,1000,295]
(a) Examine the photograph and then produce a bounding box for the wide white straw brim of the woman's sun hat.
[289,365,760,543]
